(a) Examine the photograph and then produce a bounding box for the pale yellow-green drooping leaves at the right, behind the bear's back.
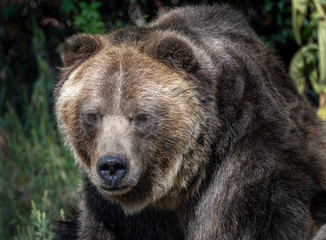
[290,0,326,120]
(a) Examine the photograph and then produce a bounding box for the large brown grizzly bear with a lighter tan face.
[54,5,326,240]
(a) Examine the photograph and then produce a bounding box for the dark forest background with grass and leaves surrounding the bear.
[0,0,326,240]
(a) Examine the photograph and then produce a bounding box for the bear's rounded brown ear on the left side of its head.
[61,34,102,68]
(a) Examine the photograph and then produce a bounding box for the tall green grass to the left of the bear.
[0,56,78,240]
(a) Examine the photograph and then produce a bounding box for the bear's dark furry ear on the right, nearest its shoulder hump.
[153,37,200,73]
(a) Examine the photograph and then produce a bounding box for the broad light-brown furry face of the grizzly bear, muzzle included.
[56,32,214,212]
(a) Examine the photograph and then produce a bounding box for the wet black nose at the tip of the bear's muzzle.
[97,155,128,184]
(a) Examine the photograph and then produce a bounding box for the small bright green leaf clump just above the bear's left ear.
[75,1,105,34]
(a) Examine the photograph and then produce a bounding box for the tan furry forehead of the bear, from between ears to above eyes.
[61,45,194,114]
